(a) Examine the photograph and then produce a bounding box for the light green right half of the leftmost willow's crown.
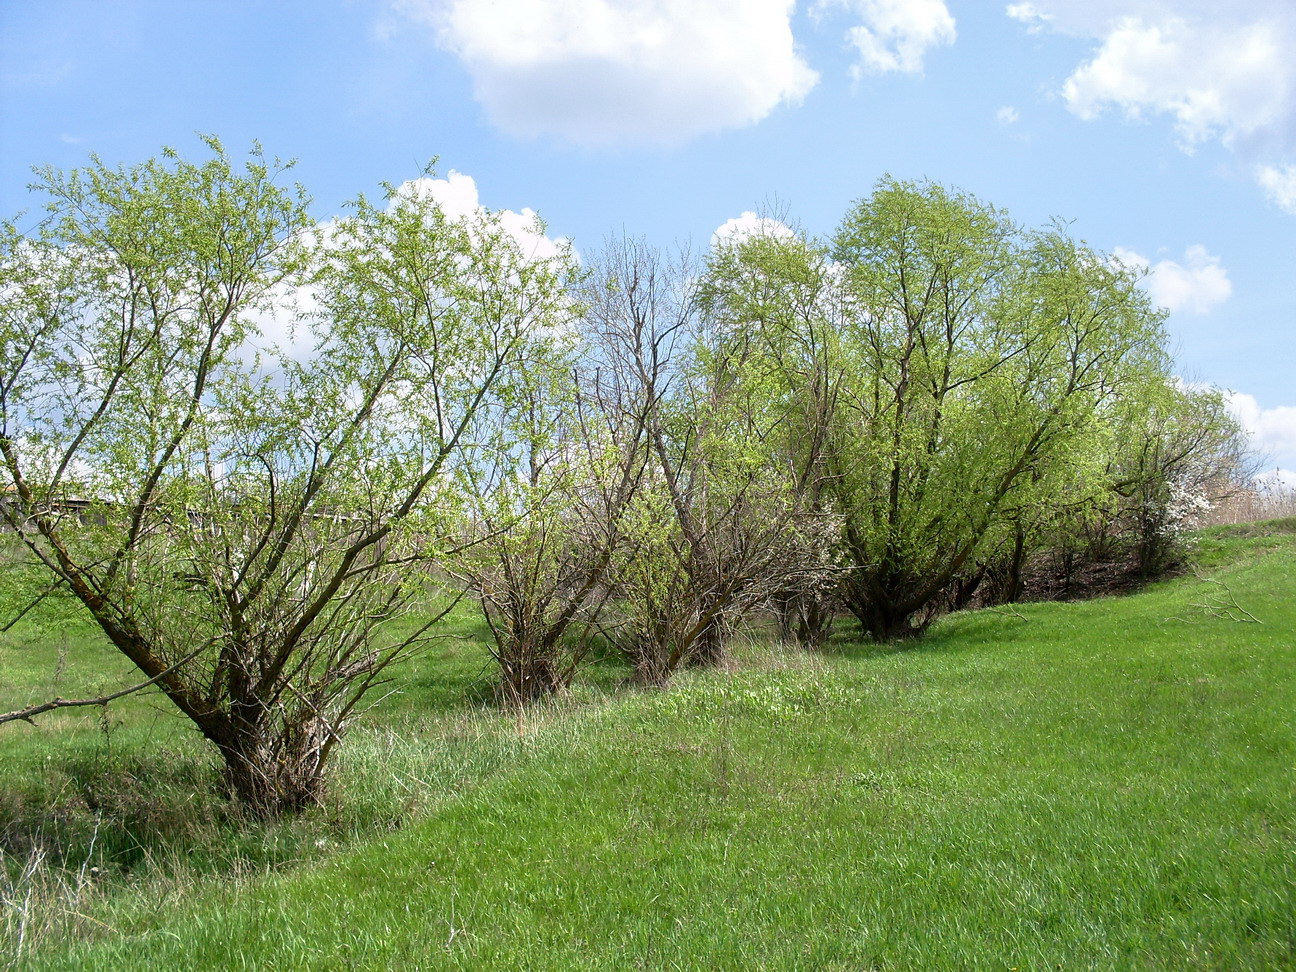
[300,173,574,549]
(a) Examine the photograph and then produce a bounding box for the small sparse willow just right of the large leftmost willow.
[454,330,644,704]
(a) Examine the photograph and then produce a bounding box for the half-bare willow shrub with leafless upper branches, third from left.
[587,241,813,684]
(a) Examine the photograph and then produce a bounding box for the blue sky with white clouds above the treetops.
[0,0,1296,470]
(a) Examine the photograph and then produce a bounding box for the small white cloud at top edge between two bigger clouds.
[816,0,958,78]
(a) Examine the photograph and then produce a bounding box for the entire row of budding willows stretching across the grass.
[0,140,1245,814]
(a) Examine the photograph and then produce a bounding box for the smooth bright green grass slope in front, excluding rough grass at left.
[10,533,1296,969]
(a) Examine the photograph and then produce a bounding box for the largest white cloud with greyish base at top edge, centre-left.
[394,0,818,145]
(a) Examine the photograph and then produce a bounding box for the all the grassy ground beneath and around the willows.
[0,522,1296,969]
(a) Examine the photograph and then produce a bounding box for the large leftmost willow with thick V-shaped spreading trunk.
[0,140,569,814]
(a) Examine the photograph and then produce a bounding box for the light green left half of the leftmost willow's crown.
[0,140,306,503]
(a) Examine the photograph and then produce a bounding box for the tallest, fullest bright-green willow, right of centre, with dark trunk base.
[833,180,1169,638]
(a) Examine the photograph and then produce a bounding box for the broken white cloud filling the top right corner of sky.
[1007,0,1296,211]
